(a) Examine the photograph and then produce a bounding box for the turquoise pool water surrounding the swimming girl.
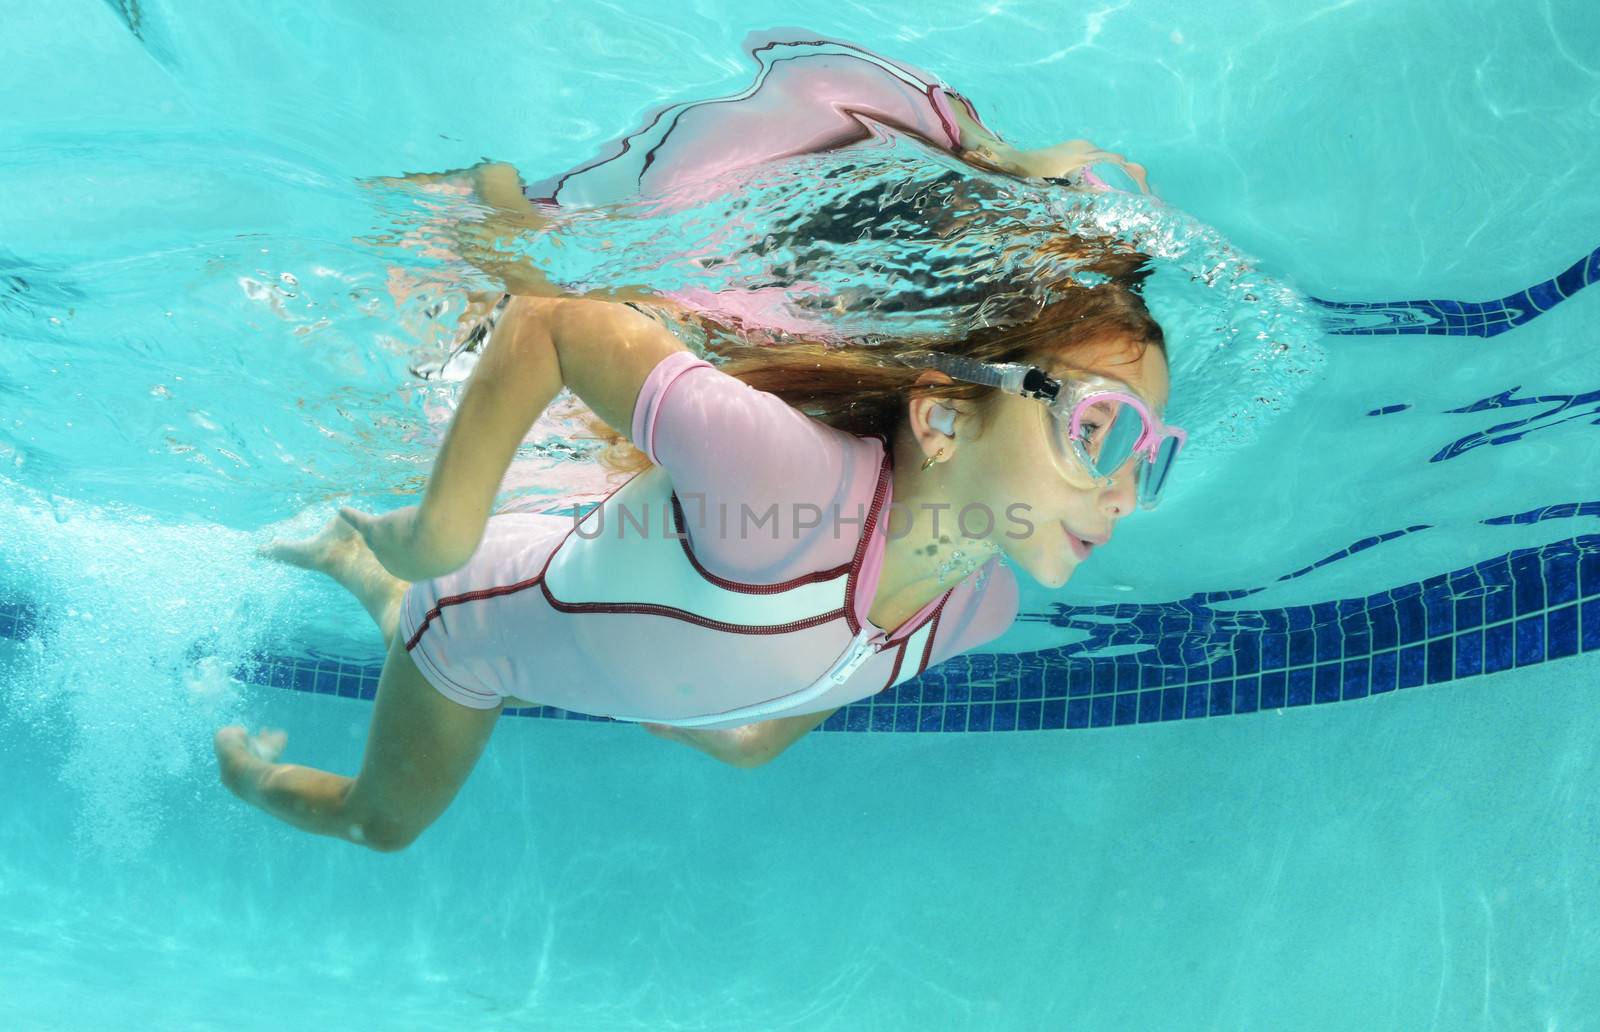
[0,0,1600,1030]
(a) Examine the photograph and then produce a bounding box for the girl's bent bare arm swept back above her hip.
[339,298,683,581]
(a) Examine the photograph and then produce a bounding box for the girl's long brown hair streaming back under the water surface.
[584,237,1166,472]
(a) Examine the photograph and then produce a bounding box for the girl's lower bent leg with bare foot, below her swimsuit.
[214,635,501,853]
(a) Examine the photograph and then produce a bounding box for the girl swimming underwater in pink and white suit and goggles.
[216,34,1184,851]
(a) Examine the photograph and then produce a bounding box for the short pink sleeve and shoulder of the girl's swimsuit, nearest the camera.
[632,350,882,582]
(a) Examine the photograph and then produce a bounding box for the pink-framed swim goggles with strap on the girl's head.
[902,350,1189,509]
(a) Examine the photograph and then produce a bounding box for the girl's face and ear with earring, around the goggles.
[950,338,1170,587]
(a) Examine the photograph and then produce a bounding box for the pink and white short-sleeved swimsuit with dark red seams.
[400,350,1018,728]
